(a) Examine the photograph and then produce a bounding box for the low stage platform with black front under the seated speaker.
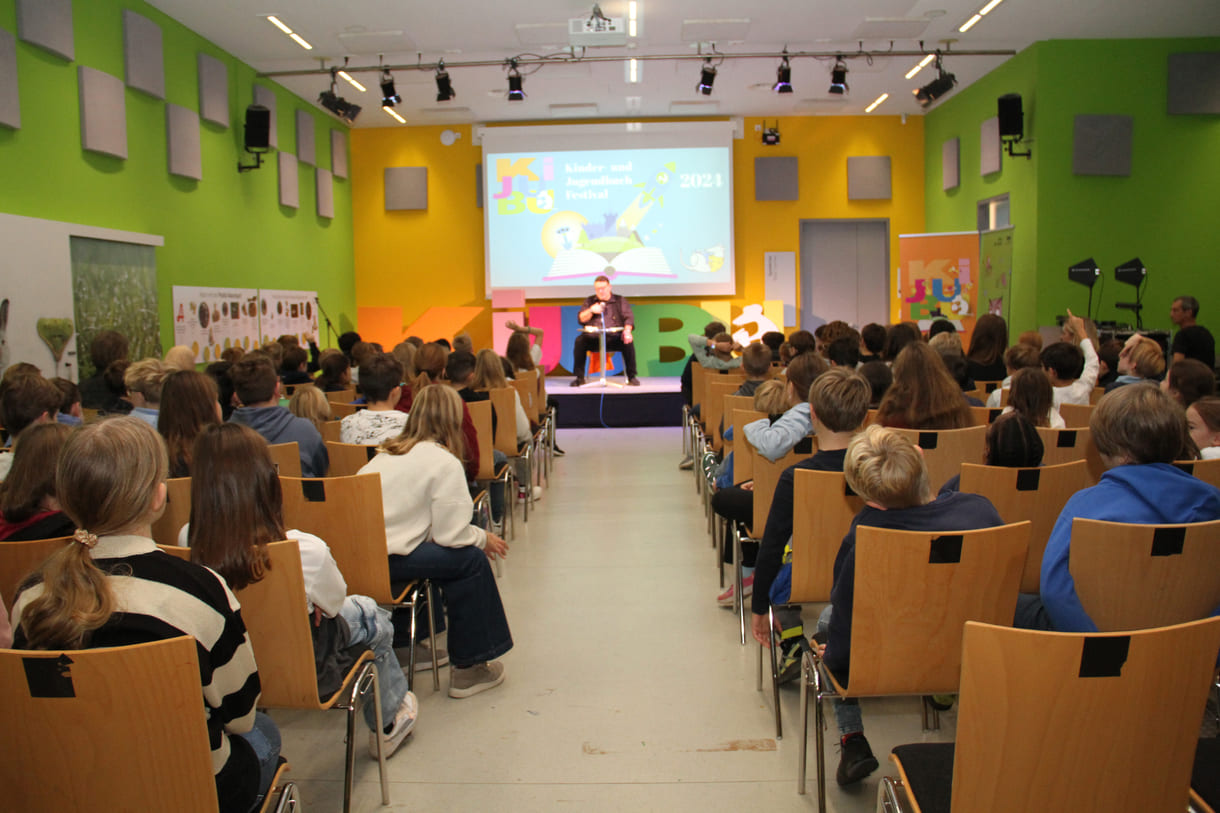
[547,376,682,428]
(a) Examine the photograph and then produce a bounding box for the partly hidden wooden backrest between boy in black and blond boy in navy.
[792,469,864,604]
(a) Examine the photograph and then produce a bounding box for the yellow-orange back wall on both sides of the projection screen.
[351,116,924,345]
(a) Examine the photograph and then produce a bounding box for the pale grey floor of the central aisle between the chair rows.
[272,428,955,813]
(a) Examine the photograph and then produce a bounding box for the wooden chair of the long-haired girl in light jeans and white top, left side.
[237,540,389,813]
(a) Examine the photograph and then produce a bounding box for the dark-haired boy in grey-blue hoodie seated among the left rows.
[229,356,331,477]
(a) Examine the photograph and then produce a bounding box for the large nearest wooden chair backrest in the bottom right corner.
[951,619,1220,813]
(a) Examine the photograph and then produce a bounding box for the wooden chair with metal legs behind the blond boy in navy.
[797,522,1029,812]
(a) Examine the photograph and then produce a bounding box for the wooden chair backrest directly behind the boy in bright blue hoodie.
[1068,519,1220,629]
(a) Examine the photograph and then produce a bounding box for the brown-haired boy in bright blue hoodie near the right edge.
[1015,383,1220,632]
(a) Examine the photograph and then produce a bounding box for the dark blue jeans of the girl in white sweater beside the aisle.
[389,542,512,668]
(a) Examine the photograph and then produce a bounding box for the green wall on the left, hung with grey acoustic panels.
[0,0,356,348]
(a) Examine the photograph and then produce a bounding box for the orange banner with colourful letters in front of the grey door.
[894,232,980,345]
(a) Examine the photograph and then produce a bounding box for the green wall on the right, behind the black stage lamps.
[925,38,1220,330]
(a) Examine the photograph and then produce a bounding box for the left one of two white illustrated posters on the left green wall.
[173,286,259,364]
